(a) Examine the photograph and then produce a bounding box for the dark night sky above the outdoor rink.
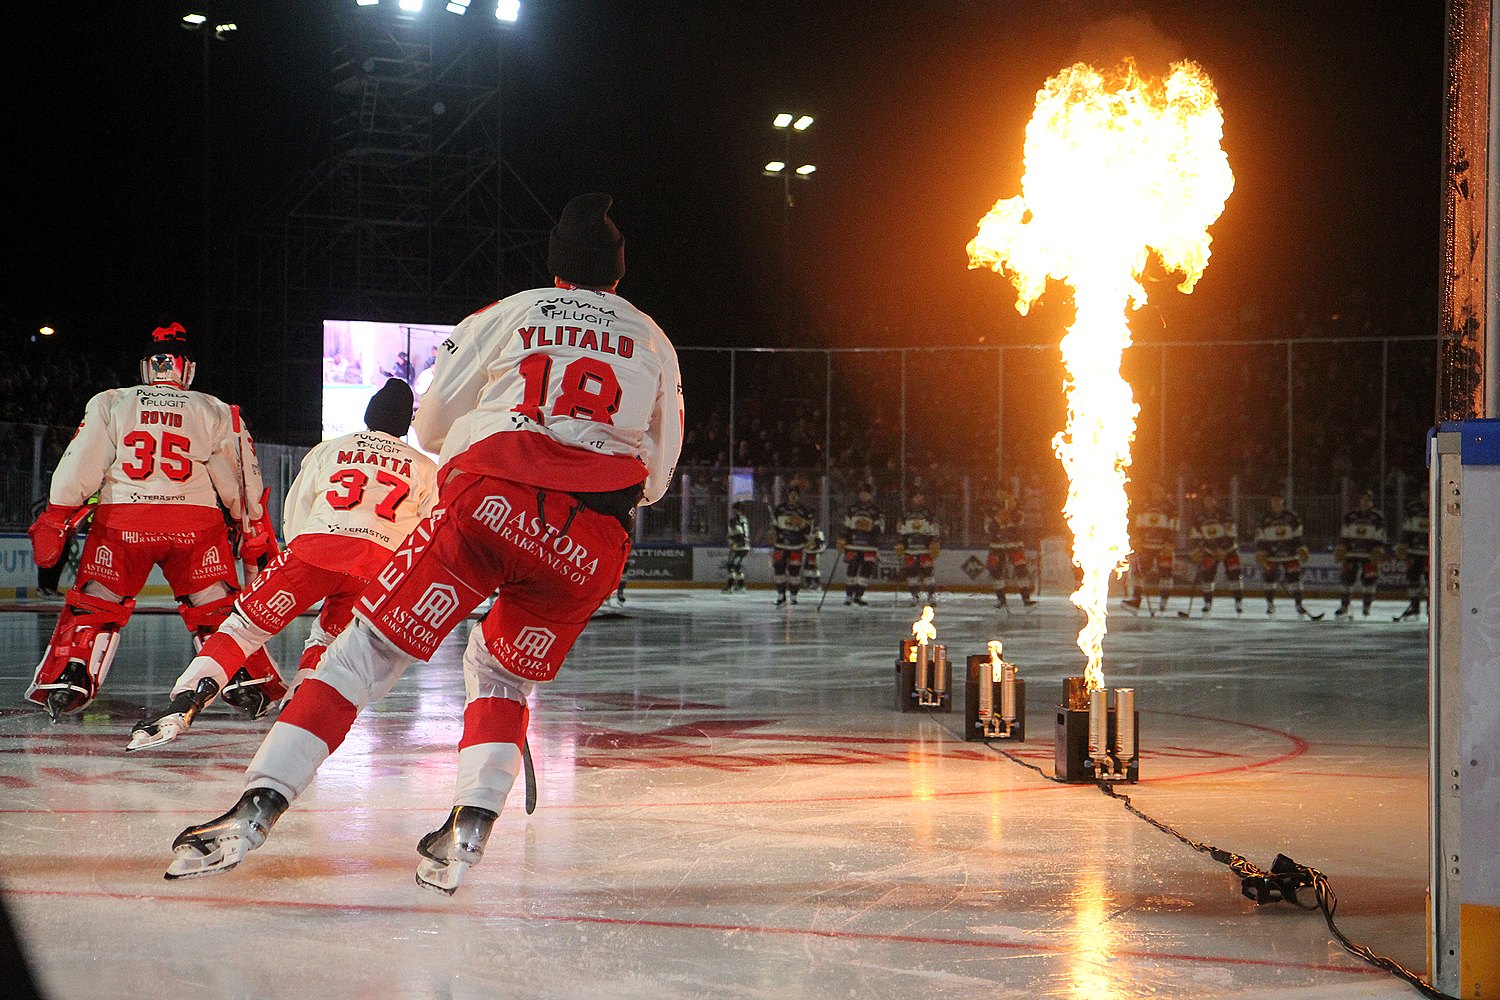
[0,0,1443,364]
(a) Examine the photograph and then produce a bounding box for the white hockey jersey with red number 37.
[282,430,438,550]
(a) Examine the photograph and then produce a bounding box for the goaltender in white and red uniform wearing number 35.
[26,322,285,721]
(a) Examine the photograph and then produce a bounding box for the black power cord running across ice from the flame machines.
[984,741,1461,1000]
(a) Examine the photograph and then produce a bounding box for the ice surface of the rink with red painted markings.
[0,586,1427,1000]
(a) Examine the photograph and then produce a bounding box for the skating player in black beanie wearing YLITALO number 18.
[167,195,683,894]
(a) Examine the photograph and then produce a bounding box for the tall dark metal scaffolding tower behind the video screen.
[210,4,554,442]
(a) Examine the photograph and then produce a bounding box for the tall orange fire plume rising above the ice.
[969,60,1235,690]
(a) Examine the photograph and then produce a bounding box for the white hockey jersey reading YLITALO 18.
[414,281,683,504]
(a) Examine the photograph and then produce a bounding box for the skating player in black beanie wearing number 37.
[126,378,438,750]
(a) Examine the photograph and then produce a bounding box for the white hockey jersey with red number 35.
[51,385,264,528]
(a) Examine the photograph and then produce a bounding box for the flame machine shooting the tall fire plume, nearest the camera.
[1055,678,1140,784]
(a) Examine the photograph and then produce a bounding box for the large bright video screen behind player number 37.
[323,319,453,441]
